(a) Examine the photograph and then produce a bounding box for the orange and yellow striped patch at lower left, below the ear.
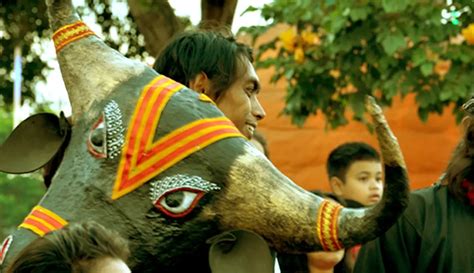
[19,205,68,237]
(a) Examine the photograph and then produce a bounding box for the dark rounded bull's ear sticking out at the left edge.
[0,113,70,174]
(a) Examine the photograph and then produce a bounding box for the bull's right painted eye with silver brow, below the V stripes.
[150,174,221,218]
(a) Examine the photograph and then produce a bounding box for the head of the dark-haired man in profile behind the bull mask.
[153,30,265,139]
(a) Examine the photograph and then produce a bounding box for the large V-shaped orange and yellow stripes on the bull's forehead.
[112,75,243,199]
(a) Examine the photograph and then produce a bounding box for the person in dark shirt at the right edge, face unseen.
[354,99,474,273]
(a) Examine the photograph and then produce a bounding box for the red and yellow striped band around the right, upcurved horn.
[316,200,344,251]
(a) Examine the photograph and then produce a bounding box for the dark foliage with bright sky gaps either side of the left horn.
[0,0,147,109]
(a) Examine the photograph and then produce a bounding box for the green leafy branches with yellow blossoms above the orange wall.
[244,0,474,128]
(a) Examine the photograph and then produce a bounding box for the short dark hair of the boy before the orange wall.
[326,142,380,183]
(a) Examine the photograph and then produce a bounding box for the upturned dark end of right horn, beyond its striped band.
[339,97,409,246]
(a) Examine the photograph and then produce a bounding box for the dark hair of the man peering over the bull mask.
[153,30,253,99]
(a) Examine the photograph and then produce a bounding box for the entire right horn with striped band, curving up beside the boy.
[212,95,409,252]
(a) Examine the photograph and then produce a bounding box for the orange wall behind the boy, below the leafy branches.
[257,70,461,190]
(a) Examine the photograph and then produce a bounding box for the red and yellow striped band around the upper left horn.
[53,21,95,53]
